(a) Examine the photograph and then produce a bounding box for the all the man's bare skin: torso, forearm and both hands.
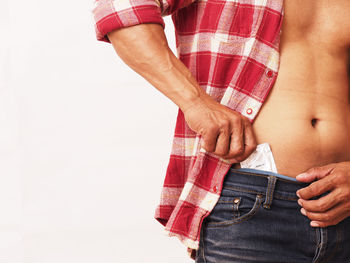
[108,0,350,227]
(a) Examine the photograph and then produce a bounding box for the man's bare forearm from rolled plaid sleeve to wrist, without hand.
[108,24,215,111]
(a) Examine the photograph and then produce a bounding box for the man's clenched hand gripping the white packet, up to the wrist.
[184,96,257,163]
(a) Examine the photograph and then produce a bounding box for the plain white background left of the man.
[0,0,193,263]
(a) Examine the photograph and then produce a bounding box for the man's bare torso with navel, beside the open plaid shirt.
[235,0,350,177]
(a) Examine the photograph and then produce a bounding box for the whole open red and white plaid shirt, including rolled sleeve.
[92,0,283,258]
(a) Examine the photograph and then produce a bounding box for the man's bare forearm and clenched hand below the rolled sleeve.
[108,24,257,163]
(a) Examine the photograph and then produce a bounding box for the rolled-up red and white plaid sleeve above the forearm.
[92,0,194,43]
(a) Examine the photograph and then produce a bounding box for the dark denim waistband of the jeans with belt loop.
[223,168,309,208]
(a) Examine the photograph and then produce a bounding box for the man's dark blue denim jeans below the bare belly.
[195,168,350,263]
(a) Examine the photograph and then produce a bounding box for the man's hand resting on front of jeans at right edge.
[296,162,350,227]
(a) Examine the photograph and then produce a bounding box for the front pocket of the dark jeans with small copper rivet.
[205,189,264,228]
